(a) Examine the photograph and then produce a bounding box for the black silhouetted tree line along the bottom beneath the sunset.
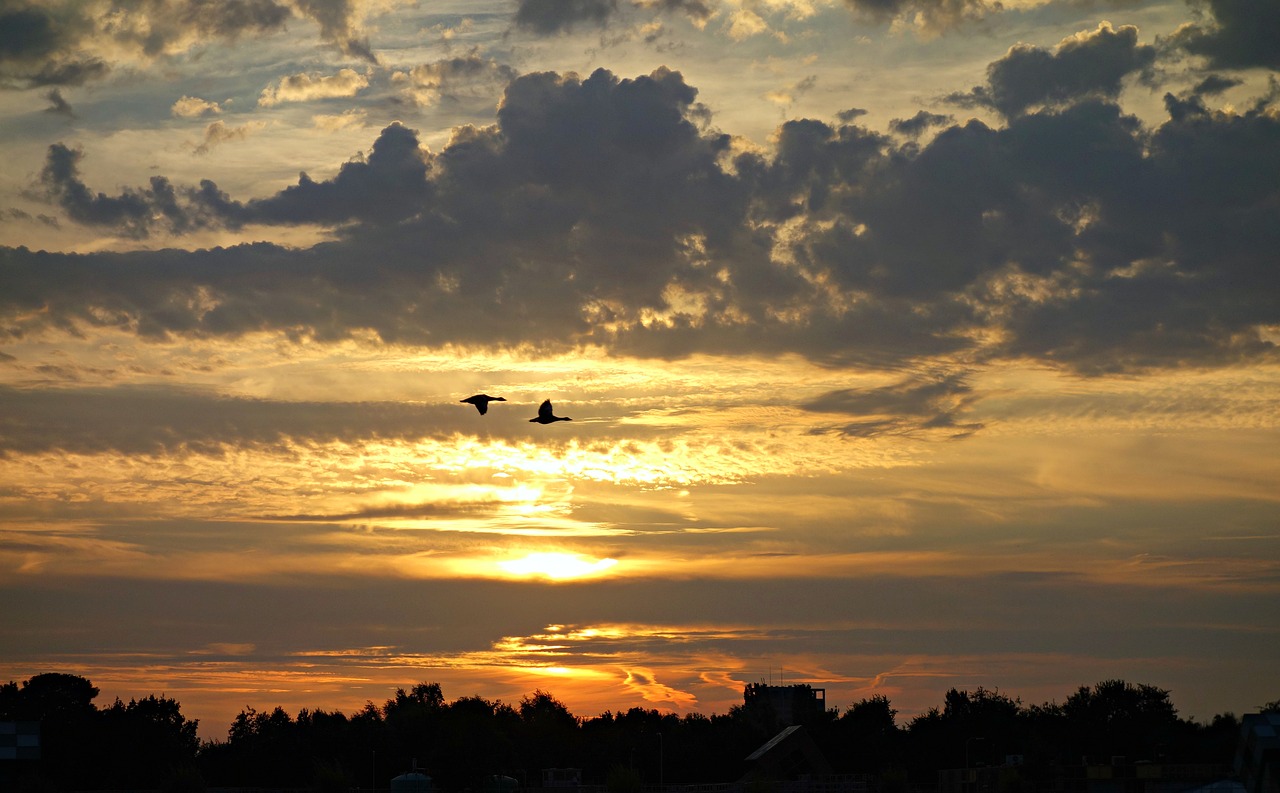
[0,673,1280,793]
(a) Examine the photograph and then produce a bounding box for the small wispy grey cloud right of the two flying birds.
[800,373,982,437]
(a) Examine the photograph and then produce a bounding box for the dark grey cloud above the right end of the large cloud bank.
[952,22,1156,118]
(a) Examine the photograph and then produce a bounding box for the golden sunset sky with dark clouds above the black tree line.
[0,0,1280,739]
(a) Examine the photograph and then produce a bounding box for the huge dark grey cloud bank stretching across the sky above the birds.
[0,58,1280,376]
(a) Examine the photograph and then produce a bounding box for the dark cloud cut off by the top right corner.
[1172,0,1280,69]
